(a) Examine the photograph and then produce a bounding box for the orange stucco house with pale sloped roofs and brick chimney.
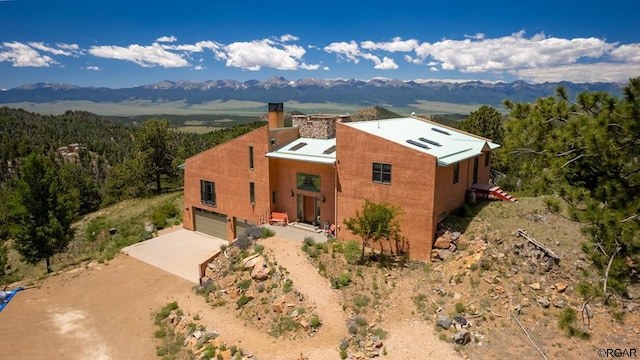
[183,103,499,260]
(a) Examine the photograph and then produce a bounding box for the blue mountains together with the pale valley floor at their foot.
[0,77,624,116]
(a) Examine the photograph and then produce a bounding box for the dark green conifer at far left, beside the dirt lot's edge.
[7,154,78,272]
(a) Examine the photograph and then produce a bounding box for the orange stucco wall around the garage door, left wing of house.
[183,126,270,240]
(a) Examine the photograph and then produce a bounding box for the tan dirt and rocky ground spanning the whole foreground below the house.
[0,199,640,360]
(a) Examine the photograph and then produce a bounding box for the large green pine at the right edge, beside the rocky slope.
[503,78,640,294]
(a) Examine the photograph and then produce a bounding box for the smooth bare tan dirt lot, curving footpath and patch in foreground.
[0,236,458,360]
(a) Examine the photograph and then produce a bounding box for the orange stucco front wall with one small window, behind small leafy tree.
[336,123,436,261]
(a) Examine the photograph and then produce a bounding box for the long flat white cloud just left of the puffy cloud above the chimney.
[89,43,189,68]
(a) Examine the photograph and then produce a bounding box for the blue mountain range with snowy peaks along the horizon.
[0,77,625,107]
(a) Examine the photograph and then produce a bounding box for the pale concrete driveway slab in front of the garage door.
[122,229,228,284]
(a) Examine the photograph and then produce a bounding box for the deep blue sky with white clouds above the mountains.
[0,0,640,89]
